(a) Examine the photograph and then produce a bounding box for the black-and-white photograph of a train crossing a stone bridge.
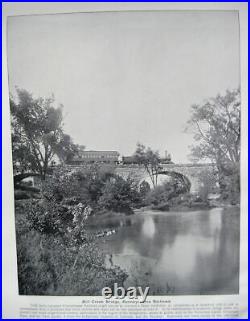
[7,10,240,296]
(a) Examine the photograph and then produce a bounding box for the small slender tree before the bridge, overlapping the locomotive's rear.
[134,143,162,187]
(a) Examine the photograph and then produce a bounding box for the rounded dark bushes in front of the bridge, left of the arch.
[42,164,141,212]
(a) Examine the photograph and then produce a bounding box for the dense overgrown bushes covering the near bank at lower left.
[16,170,127,295]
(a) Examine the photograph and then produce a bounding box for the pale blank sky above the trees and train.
[7,11,240,163]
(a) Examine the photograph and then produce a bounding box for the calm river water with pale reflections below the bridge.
[89,207,240,295]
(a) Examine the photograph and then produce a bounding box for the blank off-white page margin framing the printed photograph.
[2,2,248,318]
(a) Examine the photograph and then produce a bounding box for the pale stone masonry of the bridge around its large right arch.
[116,164,216,193]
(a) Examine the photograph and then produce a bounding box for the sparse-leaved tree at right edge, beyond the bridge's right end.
[188,89,241,199]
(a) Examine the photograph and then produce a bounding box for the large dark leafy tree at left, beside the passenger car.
[10,89,76,179]
